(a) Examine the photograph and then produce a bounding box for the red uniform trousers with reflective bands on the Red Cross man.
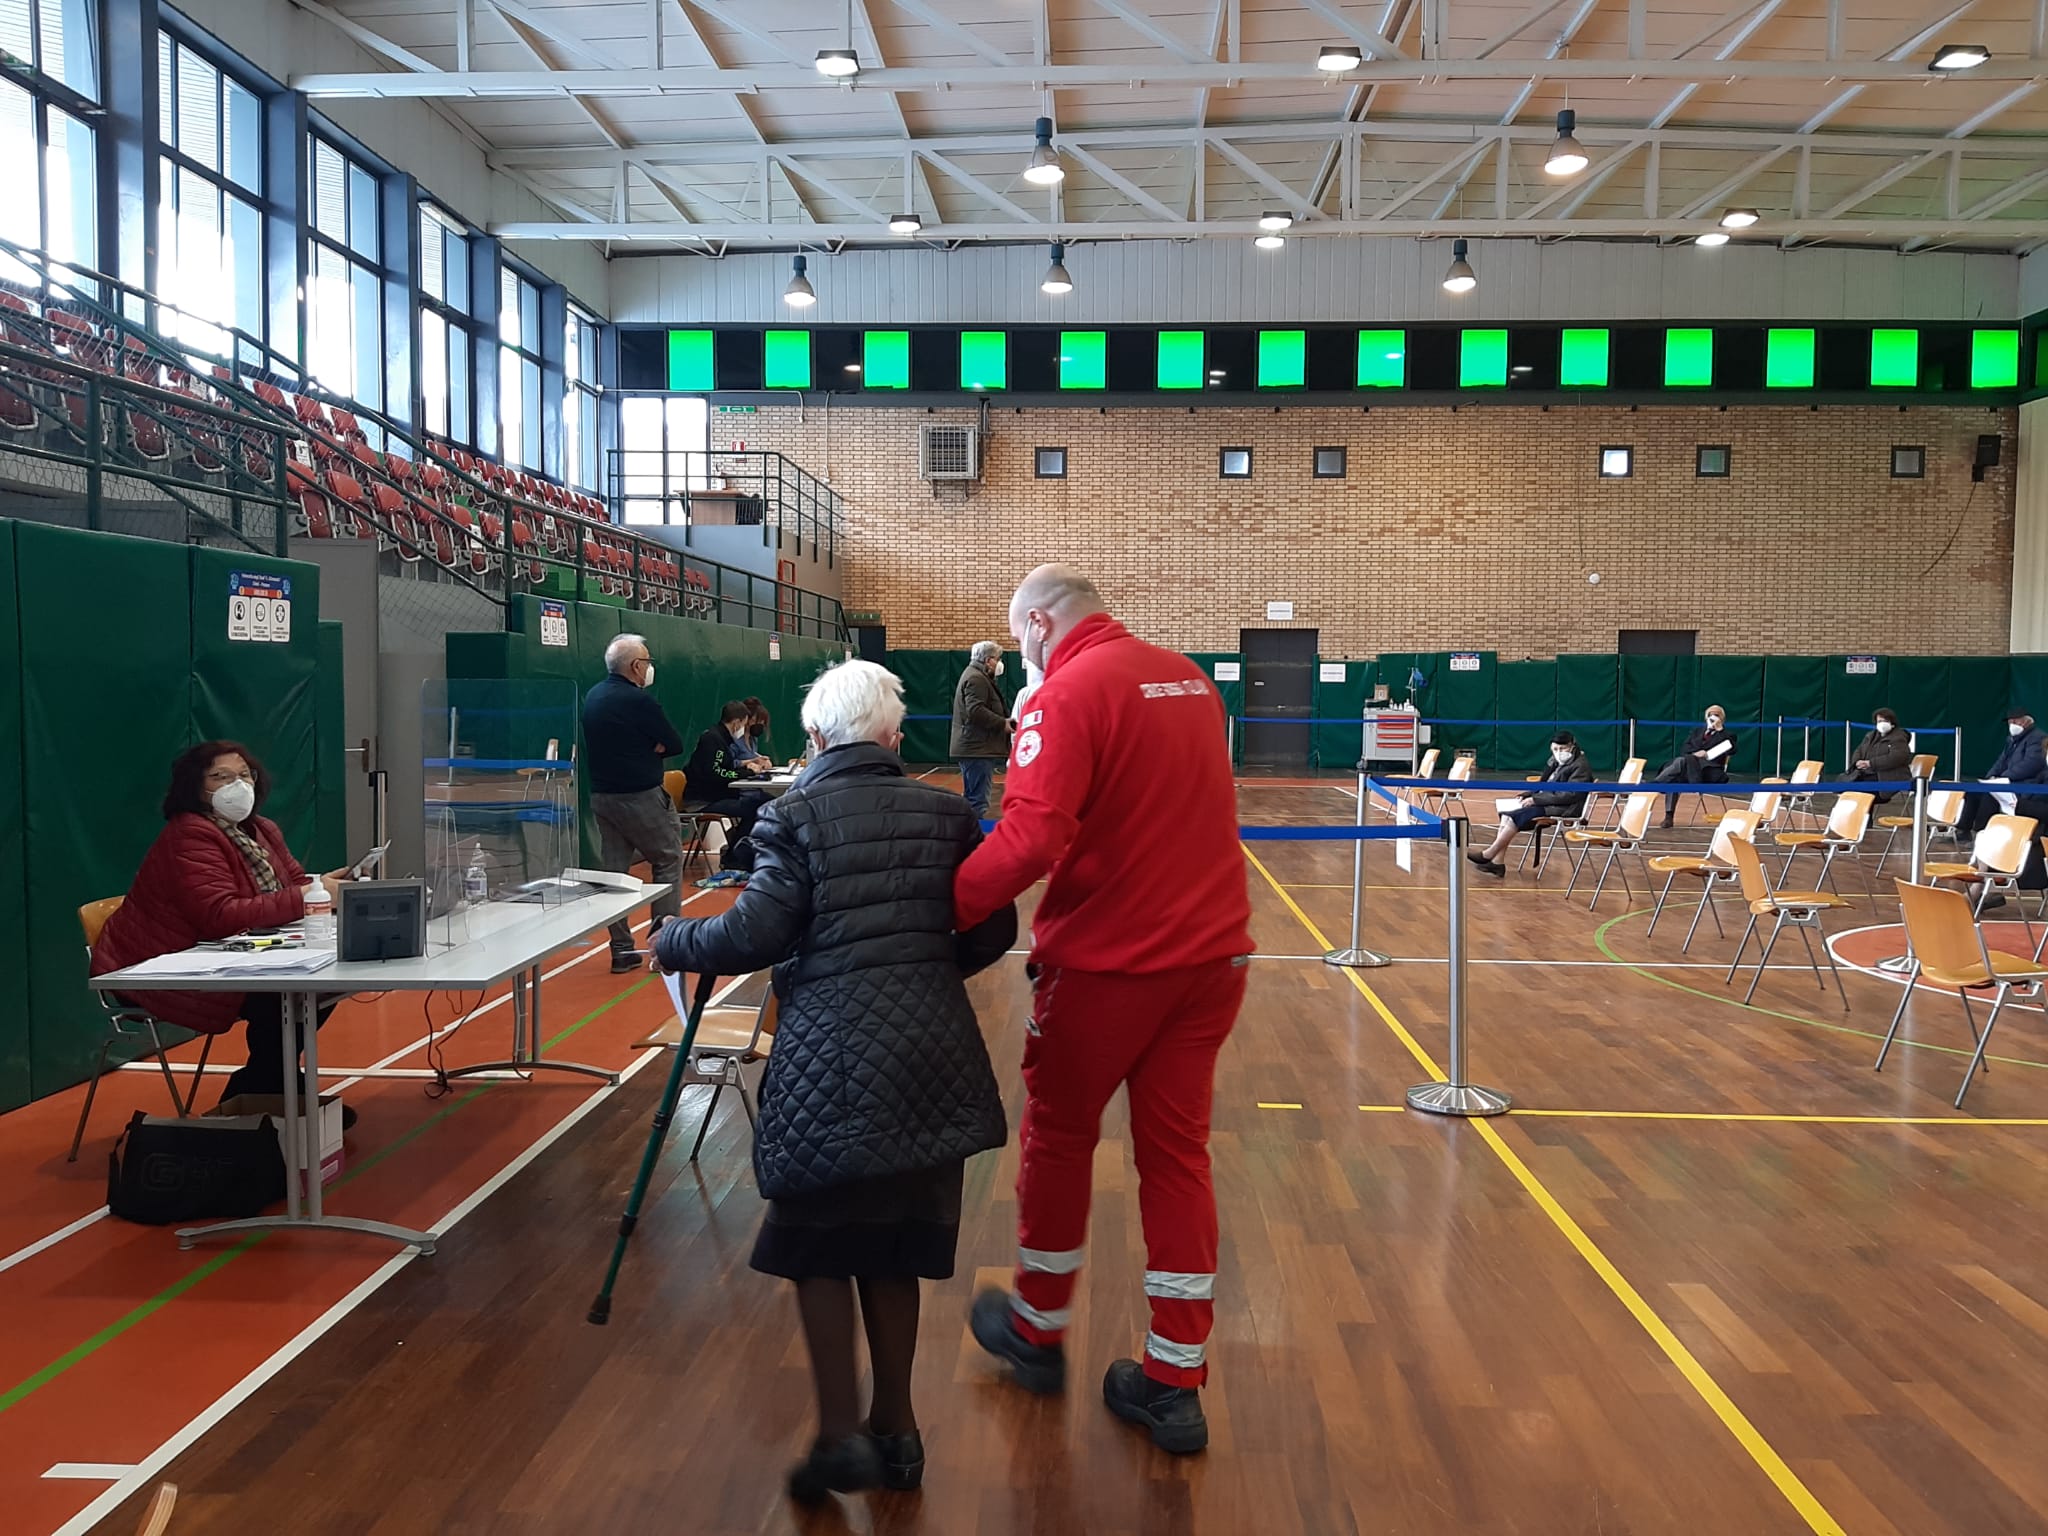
[1012,958,1245,1386]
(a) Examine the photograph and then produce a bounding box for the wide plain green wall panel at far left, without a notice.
[14,522,194,1098]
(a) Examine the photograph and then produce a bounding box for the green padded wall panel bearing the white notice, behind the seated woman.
[190,549,319,868]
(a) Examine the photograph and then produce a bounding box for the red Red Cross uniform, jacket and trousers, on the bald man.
[954,614,1251,1386]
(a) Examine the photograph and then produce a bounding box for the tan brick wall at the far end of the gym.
[711,406,2015,657]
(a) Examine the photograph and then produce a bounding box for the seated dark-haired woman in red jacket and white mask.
[92,741,354,1122]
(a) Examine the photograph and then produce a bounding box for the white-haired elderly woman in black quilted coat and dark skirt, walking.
[653,662,1018,1503]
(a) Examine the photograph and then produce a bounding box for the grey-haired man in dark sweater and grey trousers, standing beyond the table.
[584,635,682,971]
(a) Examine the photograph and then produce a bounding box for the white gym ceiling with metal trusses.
[293,0,2048,252]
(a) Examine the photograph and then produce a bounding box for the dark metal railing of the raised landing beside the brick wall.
[604,449,842,565]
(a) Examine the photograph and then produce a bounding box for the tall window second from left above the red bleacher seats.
[156,33,266,356]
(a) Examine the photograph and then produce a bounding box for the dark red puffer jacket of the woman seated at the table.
[92,813,305,1034]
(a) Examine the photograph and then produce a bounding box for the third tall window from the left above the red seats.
[305,135,385,410]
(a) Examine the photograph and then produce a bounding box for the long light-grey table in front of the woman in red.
[92,885,670,1253]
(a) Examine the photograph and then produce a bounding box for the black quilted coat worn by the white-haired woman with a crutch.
[655,743,1018,1200]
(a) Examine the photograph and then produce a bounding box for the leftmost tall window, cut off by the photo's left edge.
[0,0,100,281]
